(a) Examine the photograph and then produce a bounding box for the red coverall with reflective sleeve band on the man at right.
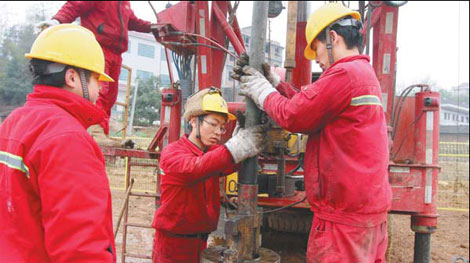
[263,55,391,263]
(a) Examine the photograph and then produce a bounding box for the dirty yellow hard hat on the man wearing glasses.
[183,87,237,121]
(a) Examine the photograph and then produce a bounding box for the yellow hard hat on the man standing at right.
[304,3,361,60]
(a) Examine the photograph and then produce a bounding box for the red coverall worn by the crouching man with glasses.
[152,136,236,263]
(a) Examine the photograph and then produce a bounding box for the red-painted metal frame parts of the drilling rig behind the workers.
[101,1,440,262]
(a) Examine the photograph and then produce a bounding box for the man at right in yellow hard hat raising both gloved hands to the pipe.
[233,3,391,263]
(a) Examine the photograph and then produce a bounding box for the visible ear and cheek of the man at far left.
[65,69,101,104]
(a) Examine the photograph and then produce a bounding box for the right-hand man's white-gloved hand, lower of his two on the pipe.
[240,66,277,110]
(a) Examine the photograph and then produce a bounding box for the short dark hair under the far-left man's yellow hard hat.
[29,58,91,88]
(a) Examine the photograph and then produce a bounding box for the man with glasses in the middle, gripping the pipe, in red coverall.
[152,88,265,263]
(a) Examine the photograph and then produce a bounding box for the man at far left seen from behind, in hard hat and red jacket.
[0,24,116,263]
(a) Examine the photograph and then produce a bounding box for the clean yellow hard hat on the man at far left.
[25,24,114,82]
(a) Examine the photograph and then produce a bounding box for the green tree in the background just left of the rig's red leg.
[131,76,162,126]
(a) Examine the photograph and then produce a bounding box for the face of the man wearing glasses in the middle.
[191,113,227,147]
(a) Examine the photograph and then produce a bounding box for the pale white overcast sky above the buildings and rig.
[0,1,469,88]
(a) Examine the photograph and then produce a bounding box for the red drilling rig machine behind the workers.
[103,1,440,263]
